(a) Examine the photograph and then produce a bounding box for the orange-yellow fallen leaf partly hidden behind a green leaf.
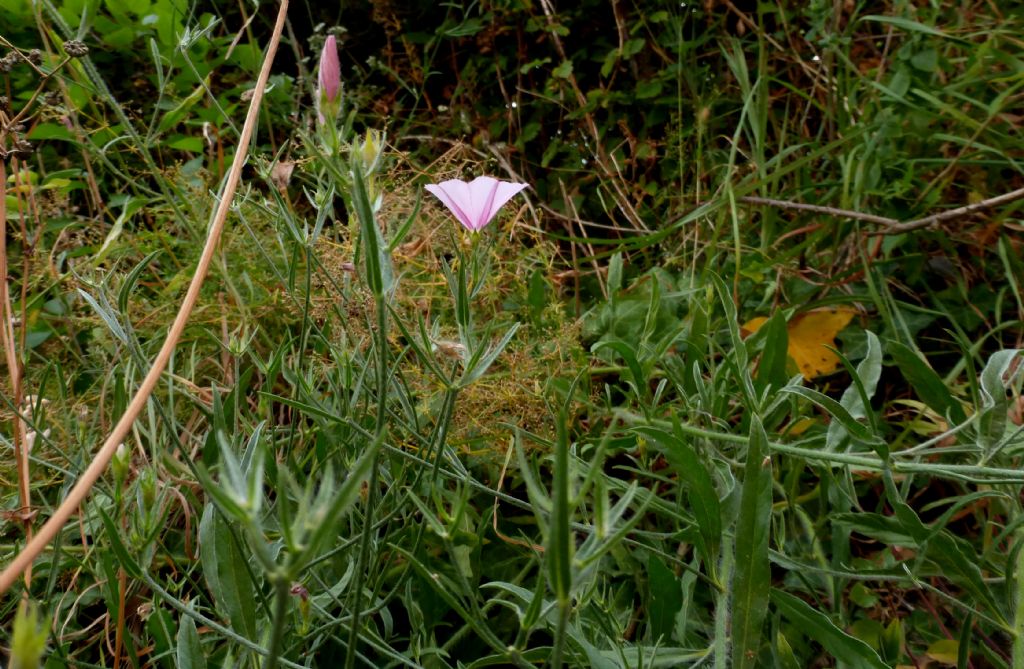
[741,307,856,379]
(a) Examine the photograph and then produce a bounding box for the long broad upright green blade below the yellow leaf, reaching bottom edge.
[732,416,772,669]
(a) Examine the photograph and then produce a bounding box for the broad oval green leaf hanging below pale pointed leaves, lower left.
[199,503,259,640]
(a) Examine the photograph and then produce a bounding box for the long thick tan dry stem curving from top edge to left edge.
[0,0,288,594]
